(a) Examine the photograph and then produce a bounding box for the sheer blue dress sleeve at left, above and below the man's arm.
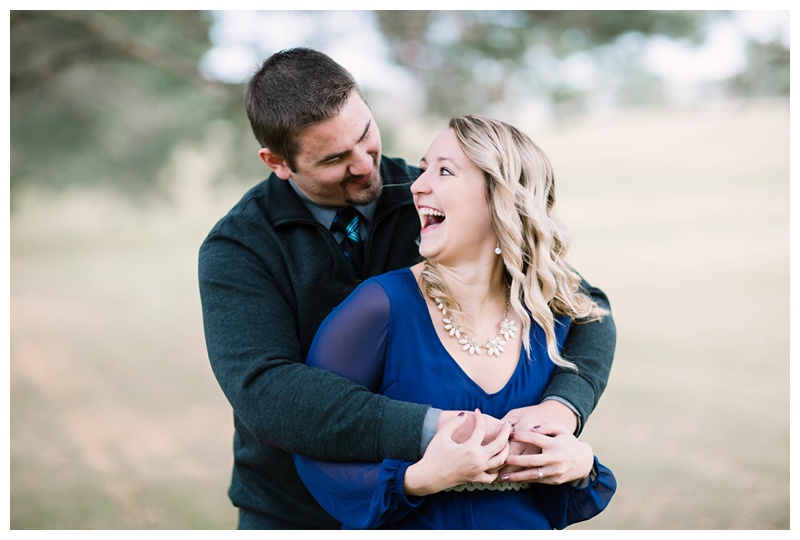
[294,280,423,529]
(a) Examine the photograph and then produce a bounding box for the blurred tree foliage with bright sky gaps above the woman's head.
[376,10,722,116]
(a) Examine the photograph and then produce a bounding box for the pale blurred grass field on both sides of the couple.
[10,102,790,530]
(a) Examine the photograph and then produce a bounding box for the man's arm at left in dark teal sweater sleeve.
[199,235,429,461]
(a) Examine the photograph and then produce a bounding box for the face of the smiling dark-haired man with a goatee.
[276,92,383,206]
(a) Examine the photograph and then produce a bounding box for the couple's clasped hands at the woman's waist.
[404,405,594,495]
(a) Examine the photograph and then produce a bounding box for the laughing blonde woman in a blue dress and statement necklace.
[295,116,616,529]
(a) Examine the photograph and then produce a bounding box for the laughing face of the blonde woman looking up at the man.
[411,128,497,265]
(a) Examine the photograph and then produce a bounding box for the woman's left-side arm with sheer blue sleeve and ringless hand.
[294,281,511,528]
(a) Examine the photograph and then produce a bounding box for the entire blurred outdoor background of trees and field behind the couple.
[9,10,790,530]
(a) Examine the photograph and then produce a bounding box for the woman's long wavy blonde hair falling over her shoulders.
[422,115,606,369]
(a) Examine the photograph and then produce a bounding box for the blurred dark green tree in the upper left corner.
[10,11,250,196]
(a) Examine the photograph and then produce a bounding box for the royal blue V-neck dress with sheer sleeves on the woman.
[295,268,616,529]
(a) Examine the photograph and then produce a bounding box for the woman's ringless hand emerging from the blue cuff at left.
[403,410,511,496]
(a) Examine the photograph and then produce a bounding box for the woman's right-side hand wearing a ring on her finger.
[500,424,594,485]
